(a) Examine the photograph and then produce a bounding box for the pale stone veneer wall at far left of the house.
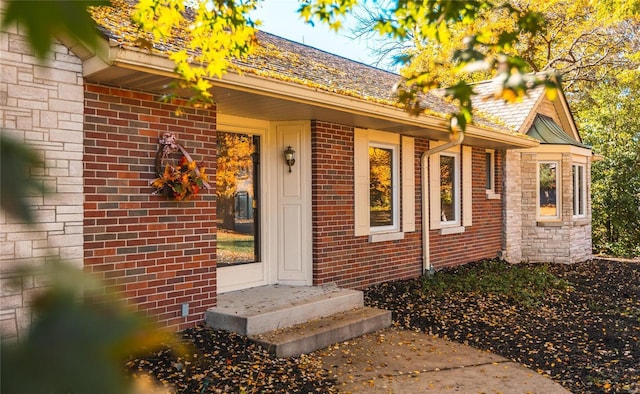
[0,23,84,340]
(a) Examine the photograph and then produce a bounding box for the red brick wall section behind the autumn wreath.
[84,84,216,329]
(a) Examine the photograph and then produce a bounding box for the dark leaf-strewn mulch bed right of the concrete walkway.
[366,260,640,393]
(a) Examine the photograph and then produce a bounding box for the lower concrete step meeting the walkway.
[249,307,391,357]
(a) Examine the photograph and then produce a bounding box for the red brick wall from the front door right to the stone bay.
[311,121,504,288]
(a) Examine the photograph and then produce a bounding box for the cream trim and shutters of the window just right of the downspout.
[429,141,473,235]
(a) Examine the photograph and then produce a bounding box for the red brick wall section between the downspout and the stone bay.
[429,148,504,269]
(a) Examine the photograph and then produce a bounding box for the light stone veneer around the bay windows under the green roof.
[504,151,592,263]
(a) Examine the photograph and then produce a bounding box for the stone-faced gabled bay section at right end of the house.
[474,81,592,263]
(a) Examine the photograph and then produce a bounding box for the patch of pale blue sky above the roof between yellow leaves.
[252,0,375,64]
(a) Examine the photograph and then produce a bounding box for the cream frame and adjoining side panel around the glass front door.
[216,114,313,293]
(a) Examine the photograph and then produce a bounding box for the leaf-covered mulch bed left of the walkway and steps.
[122,326,337,394]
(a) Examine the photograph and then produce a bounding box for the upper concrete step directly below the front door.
[205,285,364,336]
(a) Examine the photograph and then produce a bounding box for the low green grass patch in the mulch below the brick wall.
[422,260,570,307]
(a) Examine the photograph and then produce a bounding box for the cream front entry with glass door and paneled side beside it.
[216,114,312,293]
